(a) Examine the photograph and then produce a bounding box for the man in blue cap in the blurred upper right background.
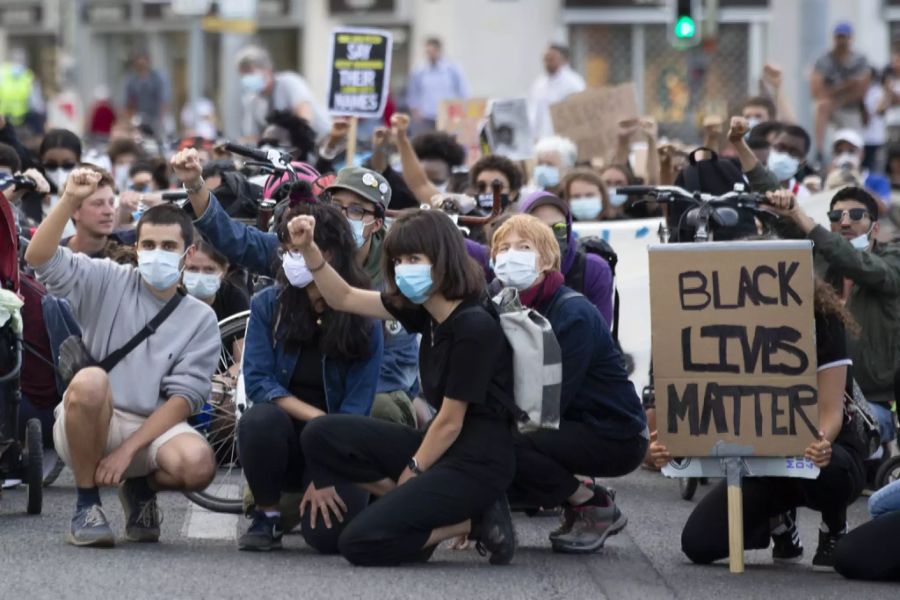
[810,22,871,162]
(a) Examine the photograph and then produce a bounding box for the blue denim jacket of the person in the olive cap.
[194,193,419,394]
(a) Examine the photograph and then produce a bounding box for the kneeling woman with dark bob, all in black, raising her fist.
[289,211,515,565]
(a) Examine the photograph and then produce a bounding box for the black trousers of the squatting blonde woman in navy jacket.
[508,421,649,508]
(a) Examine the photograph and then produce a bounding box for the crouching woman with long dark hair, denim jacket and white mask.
[238,204,382,553]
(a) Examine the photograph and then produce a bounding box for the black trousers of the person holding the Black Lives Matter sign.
[681,445,865,564]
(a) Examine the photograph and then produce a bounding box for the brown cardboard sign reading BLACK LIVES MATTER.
[649,240,819,456]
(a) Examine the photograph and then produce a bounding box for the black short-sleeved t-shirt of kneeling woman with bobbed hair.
[382,295,513,421]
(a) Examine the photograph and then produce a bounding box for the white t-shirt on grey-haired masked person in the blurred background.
[243,71,331,137]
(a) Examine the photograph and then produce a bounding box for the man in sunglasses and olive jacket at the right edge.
[773,186,900,452]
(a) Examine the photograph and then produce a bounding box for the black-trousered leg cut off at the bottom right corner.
[834,511,900,581]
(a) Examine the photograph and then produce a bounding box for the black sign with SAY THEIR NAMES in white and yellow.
[328,29,393,118]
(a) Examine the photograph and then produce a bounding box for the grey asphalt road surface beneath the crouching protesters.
[0,470,900,600]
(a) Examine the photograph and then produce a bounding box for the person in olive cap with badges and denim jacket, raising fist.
[171,149,418,434]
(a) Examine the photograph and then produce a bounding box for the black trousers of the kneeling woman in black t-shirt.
[301,415,513,566]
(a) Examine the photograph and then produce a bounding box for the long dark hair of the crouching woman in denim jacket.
[272,202,372,360]
